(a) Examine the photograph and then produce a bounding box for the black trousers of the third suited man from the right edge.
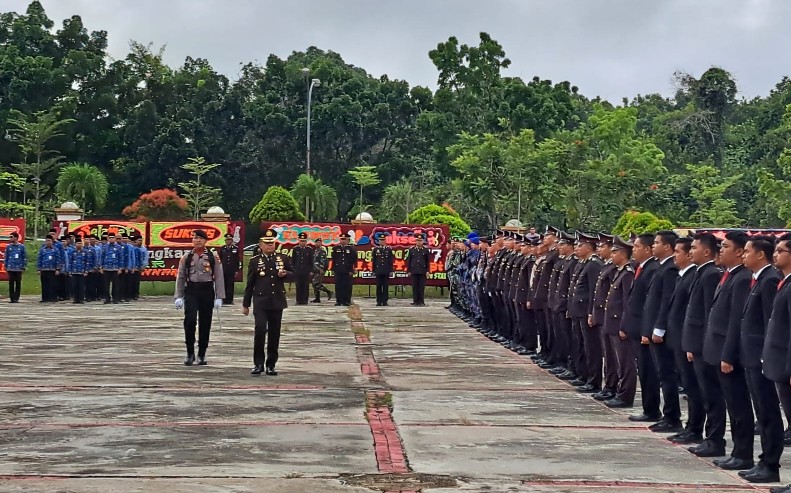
[716,365,756,460]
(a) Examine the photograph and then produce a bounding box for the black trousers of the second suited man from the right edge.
[745,366,783,471]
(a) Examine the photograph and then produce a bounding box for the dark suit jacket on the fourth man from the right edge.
[681,262,721,354]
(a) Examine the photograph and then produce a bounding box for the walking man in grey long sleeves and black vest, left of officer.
[175,229,225,366]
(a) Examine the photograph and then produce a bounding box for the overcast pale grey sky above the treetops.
[6,0,791,102]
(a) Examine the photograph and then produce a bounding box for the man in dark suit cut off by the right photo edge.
[763,233,791,493]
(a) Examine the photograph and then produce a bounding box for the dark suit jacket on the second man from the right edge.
[739,265,780,368]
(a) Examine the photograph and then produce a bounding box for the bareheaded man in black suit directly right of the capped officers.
[624,234,662,422]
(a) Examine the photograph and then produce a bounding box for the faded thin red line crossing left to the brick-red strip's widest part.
[0,421,366,430]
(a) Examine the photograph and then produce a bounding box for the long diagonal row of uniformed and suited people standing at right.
[449,228,791,493]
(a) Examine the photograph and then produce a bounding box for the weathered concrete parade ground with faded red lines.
[0,297,791,493]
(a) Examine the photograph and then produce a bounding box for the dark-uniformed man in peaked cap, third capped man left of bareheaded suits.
[568,232,603,394]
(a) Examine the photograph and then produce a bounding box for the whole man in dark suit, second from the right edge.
[736,236,783,483]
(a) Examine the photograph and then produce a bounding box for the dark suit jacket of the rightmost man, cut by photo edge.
[763,272,791,384]
